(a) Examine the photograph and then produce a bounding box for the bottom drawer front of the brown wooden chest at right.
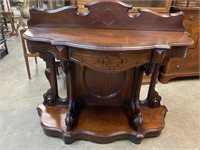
[169,58,199,74]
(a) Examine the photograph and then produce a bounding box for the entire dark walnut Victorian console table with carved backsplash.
[23,0,193,144]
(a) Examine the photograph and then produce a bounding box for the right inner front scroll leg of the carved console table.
[131,66,143,131]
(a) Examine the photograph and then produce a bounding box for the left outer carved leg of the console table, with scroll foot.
[40,52,59,105]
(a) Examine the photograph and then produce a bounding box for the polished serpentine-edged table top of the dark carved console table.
[24,27,193,51]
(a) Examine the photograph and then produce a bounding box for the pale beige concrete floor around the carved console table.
[0,33,200,150]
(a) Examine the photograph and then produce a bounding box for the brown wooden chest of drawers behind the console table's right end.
[159,0,200,83]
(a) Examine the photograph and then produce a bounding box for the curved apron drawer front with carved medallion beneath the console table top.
[69,48,151,72]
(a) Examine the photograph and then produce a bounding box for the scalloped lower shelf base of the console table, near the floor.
[37,104,167,144]
